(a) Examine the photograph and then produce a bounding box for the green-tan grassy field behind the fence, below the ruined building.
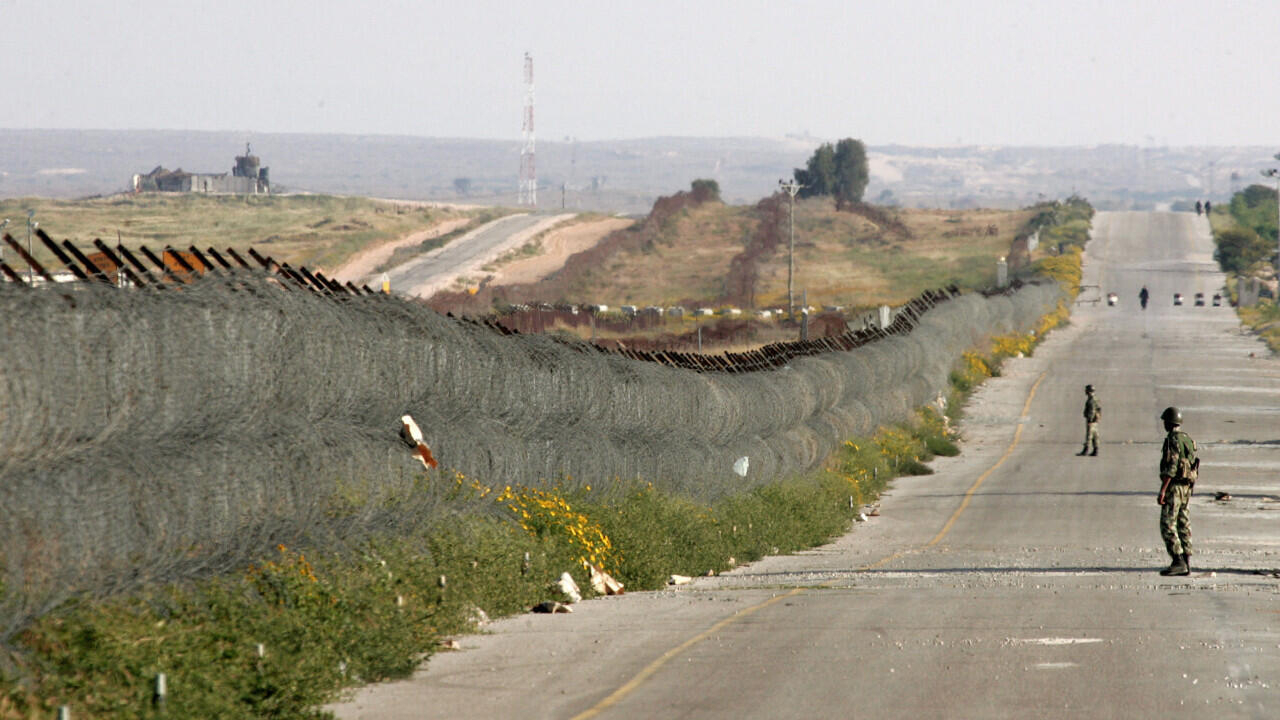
[0,193,494,272]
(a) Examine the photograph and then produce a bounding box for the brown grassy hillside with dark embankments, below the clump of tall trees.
[431,192,1033,313]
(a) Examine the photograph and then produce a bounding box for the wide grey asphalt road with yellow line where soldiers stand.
[335,213,1280,719]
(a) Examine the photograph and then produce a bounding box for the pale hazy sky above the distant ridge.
[10,0,1280,145]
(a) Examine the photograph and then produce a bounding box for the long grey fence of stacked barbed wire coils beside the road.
[0,272,1061,632]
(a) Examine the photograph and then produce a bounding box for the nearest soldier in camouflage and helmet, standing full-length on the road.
[1156,407,1199,575]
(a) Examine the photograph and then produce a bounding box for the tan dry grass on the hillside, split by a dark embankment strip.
[558,199,1032,307]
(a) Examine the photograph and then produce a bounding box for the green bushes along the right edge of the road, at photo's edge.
[1210,184,1280,352]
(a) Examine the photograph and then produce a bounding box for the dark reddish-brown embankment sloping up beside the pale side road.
[429,184,713,314]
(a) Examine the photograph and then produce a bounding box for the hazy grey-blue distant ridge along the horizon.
[0,129,1274,213]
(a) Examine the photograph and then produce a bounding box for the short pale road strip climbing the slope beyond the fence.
[387,214,571,297]
